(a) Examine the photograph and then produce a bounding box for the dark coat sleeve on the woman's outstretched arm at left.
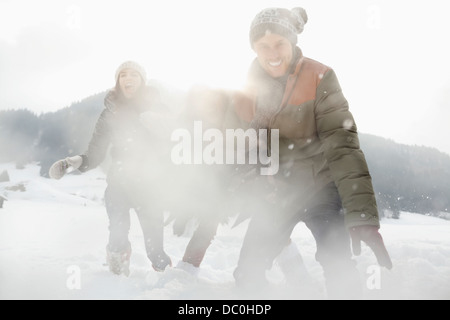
[79,109,112,172]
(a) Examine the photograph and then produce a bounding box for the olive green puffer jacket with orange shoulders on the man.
[235,48,379,227]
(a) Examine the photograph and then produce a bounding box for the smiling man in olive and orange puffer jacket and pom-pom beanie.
[234,8,392,297]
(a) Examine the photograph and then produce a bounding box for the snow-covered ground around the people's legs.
[0,164,450,300]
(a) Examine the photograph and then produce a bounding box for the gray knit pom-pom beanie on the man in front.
[250,8,308,46]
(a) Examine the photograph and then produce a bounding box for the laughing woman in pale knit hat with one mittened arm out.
[49,61,171,276]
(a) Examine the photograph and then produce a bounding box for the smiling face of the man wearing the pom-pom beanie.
[253,33,293,78]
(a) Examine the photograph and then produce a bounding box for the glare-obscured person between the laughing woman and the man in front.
[167,86,239,274]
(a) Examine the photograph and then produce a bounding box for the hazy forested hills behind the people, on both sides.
[0,92,450,218]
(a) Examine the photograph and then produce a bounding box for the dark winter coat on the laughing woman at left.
[80,87,170,192]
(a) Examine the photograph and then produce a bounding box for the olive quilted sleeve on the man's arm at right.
[315,70,379,228]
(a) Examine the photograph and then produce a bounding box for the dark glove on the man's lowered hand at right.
[349,225,392,270]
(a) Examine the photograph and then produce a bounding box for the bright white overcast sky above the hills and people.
[0,0,450,154]
